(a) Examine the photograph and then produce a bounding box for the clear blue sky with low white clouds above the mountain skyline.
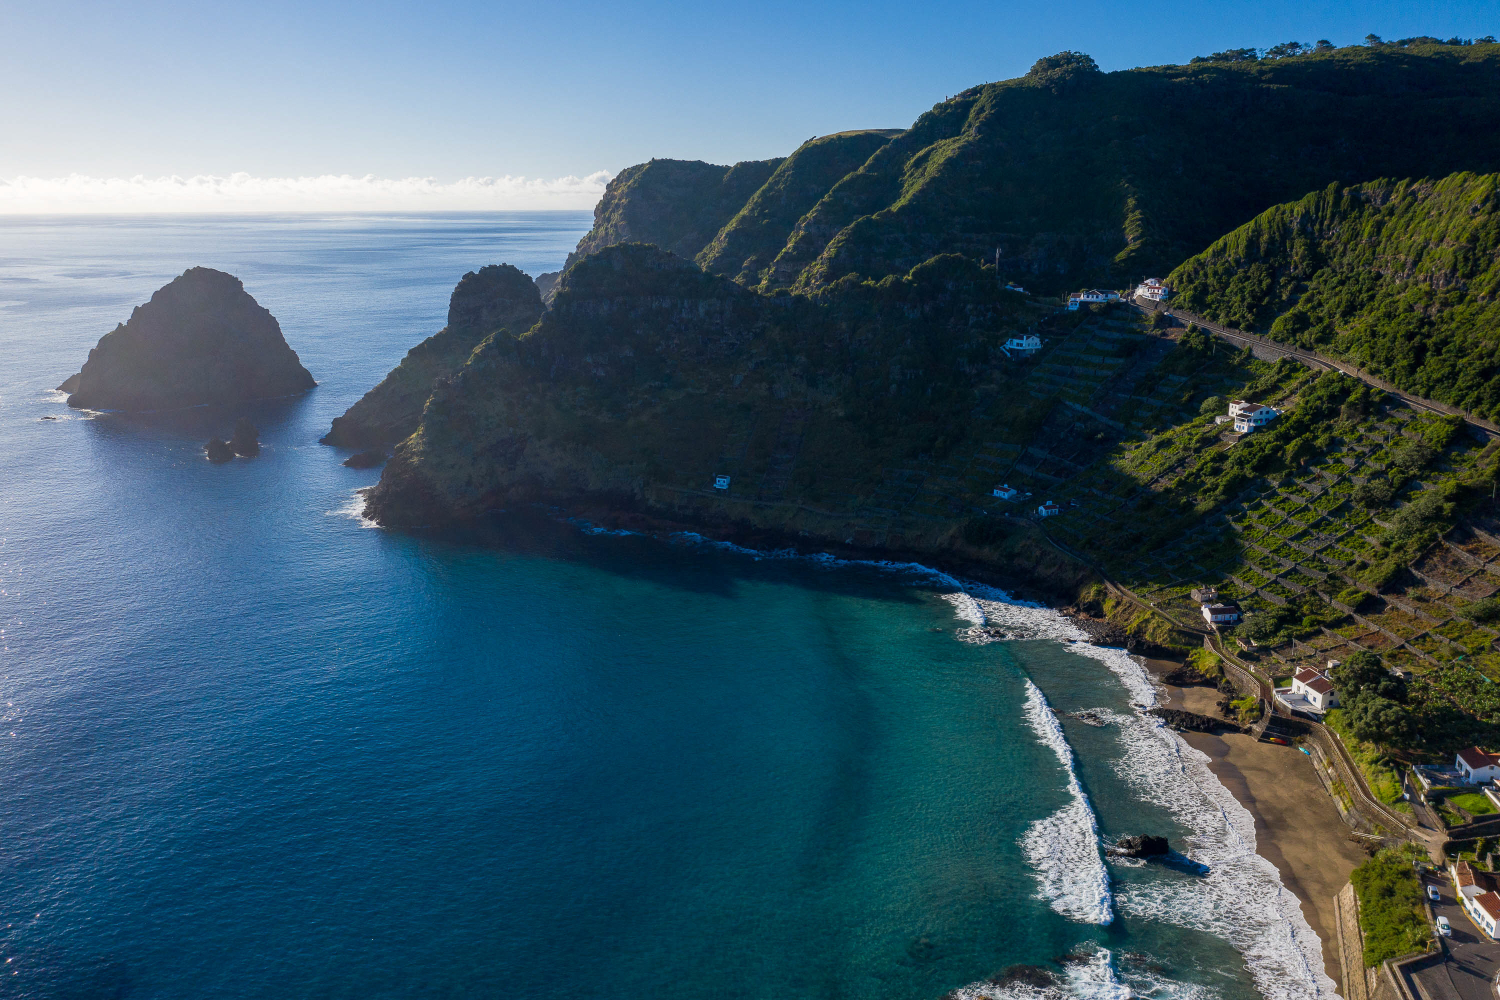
[0,0,1500,214]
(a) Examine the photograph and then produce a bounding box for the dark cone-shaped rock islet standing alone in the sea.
[59,267,317,411]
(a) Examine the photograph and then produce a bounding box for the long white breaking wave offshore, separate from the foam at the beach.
[1022,679,1115,924]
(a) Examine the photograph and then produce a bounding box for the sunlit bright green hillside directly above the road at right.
[1169,174,1500,417]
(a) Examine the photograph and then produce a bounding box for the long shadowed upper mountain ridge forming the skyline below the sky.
[558,43,1500,294]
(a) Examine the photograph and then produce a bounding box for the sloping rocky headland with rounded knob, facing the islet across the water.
[323,264,543,448]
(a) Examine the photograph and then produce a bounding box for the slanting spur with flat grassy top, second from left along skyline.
[698,129,900,285]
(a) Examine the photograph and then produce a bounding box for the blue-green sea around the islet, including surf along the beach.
[0,213,1332,1000]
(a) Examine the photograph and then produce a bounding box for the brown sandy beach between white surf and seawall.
[1146,660,1365,990]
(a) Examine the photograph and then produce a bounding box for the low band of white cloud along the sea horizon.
[0,171,611,216]
